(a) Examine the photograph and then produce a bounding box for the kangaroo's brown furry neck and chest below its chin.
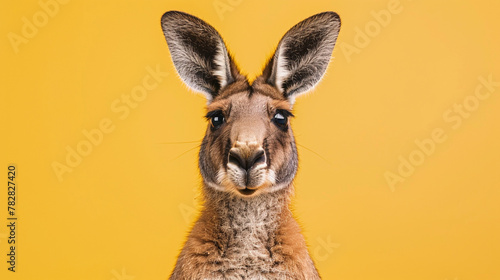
[170,188,319,279]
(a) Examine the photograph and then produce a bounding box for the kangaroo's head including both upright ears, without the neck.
[161,11,340,196]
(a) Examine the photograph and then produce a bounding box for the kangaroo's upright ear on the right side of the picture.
[262,12,340,104]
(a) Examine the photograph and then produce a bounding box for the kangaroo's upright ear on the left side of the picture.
[161,11,239,102]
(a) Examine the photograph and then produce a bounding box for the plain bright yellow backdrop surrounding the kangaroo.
[0,0,500,280]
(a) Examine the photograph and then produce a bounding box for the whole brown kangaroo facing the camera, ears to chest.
[161,11,340,280]
